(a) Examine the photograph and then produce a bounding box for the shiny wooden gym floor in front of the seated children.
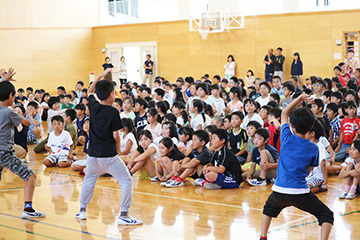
[0,147,360,240]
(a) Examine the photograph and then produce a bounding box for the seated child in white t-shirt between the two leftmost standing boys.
[43,116,74,167]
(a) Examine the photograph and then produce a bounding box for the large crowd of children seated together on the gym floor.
[4,57,360,199]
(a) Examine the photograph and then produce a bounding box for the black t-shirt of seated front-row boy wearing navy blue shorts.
[210,146,243,184]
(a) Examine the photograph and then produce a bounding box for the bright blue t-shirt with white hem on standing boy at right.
[271,124,319,195]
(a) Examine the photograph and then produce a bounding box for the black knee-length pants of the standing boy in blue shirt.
[263,192,334,226]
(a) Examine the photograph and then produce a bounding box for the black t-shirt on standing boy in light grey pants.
[88,95,123,157]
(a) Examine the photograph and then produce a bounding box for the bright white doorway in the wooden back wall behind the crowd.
[105,42,157,89]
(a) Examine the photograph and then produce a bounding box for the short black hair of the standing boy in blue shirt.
[290,108,316,134]
